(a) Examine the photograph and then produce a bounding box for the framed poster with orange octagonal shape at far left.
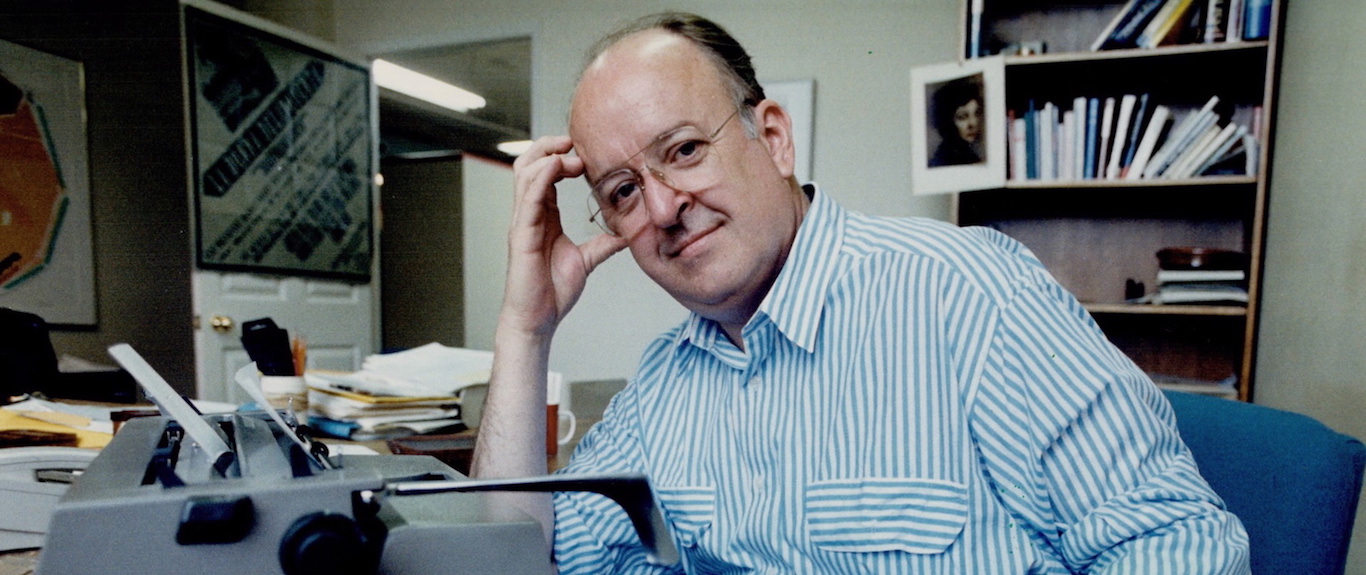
[0,41,96,325]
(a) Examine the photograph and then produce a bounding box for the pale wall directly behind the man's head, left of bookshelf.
[333,0,959,381]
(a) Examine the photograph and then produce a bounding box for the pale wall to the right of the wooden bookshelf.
[1255,0,1366,575]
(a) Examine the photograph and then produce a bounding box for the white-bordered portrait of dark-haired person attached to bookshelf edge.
[911,57,1007,194]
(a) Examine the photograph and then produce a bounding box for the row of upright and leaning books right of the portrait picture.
[1007,94,1261,182]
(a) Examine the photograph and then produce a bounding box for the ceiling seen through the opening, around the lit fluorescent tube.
[377,38,531,161]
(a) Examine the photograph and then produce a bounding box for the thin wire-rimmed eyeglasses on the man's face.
[589,108,740,238]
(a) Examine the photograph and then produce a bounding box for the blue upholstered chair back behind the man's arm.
[1167,391,1366,575]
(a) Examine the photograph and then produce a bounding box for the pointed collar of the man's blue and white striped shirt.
[675,183,846,351]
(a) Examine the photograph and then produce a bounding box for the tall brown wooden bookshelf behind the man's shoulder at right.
[939,0,1281,400]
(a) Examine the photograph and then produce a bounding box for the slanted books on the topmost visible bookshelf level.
[1091,0,1272,51]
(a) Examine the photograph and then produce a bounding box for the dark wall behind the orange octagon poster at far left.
[0,0,194,392]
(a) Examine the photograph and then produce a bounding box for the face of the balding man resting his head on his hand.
[570,31,805,325]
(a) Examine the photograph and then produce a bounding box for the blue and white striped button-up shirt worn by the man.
[555,185,1249,574]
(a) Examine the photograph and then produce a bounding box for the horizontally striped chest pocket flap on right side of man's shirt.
[805,478,967,555]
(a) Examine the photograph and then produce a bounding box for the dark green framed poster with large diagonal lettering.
[184,7,374,281]
